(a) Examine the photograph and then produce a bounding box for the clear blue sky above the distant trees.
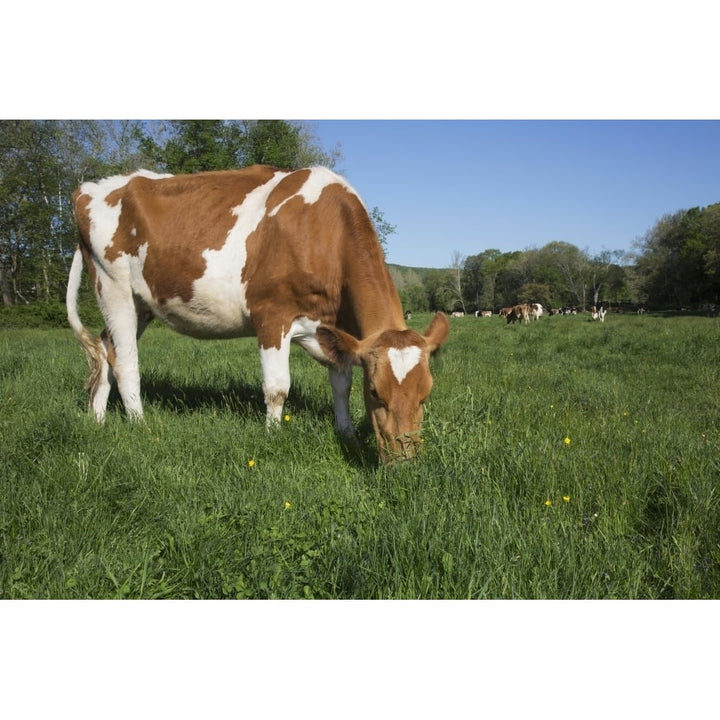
[310,120,720,267]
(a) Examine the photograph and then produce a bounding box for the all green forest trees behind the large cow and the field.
[0,120,720,317]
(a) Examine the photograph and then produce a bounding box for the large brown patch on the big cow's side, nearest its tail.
[105,166,275,303]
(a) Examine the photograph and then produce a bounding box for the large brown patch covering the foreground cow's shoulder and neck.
[242,179,405,347]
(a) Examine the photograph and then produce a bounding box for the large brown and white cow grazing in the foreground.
[67,165,449,463]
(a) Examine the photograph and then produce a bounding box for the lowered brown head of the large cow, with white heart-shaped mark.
[317,313,450,463]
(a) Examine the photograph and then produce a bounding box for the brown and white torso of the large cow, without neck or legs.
[76,166,376,337]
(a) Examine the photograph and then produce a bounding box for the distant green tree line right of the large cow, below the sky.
[391,210,720,313]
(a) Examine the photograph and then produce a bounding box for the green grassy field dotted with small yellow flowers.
[0,314,720,599]
